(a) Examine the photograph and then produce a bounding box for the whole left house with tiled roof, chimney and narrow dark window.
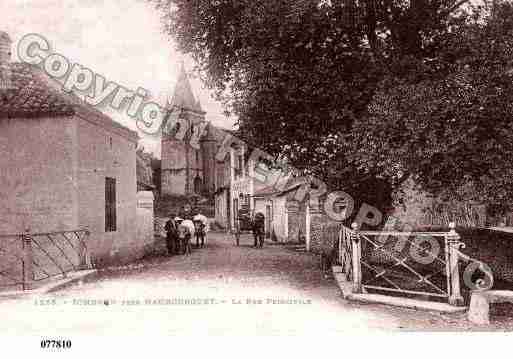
[0,33,147,265]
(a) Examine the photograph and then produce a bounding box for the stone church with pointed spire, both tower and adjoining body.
[160,66,222,197]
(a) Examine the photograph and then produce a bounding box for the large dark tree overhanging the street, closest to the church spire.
[149,0,496,211]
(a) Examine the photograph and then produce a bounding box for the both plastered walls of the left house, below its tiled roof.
[0,115,145,286]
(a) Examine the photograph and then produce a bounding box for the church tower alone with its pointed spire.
[161,64,205,196]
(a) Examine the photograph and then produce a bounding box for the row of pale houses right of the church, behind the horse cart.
[215,141,310,241]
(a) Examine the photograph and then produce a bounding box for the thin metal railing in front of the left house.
[0,229,92,290]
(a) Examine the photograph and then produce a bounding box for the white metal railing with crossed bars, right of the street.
[338,224,464,305]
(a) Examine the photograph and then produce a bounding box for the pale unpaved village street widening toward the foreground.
[0,233,511,335]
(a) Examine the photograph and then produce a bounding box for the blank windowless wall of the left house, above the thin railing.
[0,117,78,234]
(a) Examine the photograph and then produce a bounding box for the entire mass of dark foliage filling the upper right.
[149,0,513,212]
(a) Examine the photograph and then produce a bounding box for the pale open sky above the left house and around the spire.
[0,0,234,156]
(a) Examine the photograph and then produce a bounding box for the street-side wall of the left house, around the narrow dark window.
[76,118,138,266]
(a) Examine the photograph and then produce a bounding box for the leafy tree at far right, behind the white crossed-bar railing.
[347,2,513,211]
